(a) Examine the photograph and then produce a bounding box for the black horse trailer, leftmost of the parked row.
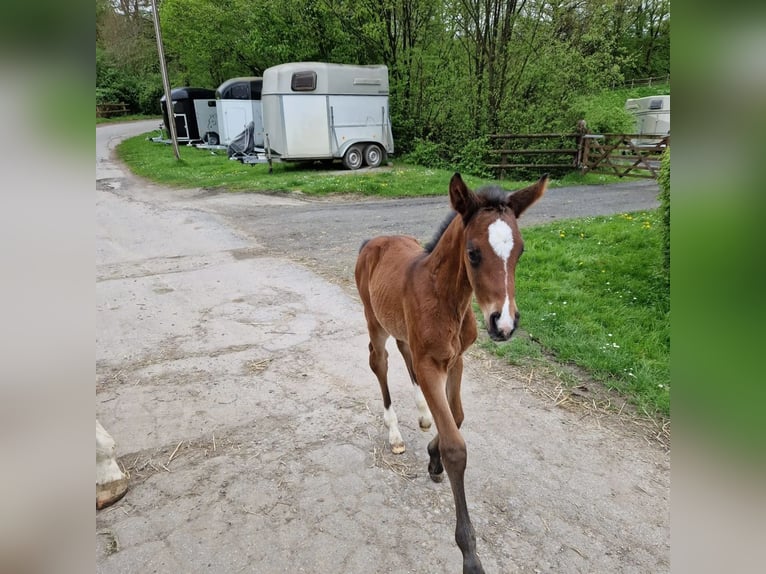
[160,87,218,143]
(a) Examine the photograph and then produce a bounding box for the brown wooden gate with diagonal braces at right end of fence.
[579,134,670,179]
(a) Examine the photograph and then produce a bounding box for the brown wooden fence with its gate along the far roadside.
[487,132,670,179]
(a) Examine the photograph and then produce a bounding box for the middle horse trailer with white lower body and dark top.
[215,77,263,147]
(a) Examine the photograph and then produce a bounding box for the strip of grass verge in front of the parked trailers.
[117,132,624,197]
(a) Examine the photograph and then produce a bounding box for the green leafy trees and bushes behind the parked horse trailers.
[96,0,670,153]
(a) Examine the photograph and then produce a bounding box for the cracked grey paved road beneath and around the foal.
[95,122,670,574]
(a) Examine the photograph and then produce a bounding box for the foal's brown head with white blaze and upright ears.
[449,173,548,341]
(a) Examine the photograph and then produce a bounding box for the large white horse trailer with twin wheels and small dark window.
[261,62,394,169]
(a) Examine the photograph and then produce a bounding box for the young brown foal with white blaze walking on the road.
[355,173,548,574]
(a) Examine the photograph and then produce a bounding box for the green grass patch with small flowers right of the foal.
[485,211,670,417]
